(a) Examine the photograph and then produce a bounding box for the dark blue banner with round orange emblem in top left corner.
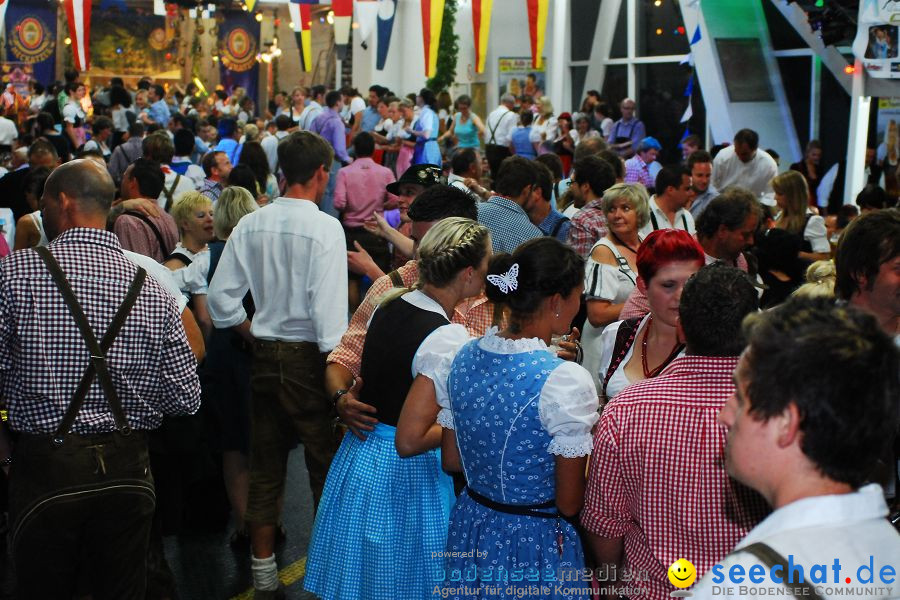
[6,1,56,84]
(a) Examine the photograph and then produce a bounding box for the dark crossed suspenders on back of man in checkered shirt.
[35,246,147,444]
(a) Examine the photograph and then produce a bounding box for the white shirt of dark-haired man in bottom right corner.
[691,484,900,599]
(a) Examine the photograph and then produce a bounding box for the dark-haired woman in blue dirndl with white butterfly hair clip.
[397,237,598,599]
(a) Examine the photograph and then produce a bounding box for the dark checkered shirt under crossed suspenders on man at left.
[0,228,200,434]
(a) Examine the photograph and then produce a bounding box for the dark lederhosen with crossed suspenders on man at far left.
[10,247,155,592]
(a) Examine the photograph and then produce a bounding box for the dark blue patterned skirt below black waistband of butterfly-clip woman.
[441,491,591,600]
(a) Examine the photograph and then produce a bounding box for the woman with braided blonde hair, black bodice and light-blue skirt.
[303,217,491,600]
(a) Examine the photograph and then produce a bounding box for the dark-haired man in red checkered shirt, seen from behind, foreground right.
[581,263,767,599]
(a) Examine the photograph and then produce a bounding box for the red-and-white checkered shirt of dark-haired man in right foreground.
[581,356,768,599]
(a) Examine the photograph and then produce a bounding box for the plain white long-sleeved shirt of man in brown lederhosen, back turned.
[208,197,347,352]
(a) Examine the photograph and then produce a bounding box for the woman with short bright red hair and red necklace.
[599,229,705,400]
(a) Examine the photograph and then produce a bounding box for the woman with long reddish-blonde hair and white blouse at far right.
[772,171,831,263]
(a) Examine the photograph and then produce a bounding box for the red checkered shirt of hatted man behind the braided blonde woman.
[328,260,494,377]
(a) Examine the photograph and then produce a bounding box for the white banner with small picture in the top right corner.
[853,0,900,79]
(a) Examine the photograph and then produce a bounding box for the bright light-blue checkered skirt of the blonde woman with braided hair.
[303,423,455,600]
